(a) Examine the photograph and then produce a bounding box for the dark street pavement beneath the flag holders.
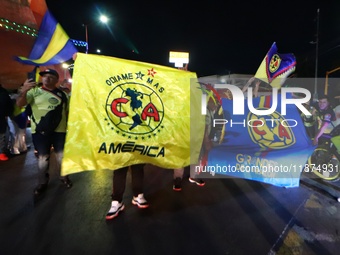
[0,129,340,255]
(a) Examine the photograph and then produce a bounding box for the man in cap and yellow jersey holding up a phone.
[16,69,72,196]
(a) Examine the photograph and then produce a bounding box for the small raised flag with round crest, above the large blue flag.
[255,42,296,88]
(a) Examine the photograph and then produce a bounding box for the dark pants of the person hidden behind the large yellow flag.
[112,164,145,203]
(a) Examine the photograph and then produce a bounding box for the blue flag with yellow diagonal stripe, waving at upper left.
[16,11,77,66]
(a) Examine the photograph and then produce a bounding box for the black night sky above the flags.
[46,0,340,77]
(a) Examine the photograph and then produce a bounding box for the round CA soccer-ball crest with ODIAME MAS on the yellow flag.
[105,69,164,140]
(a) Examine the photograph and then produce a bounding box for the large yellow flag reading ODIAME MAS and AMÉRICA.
[62,53,204,175]
